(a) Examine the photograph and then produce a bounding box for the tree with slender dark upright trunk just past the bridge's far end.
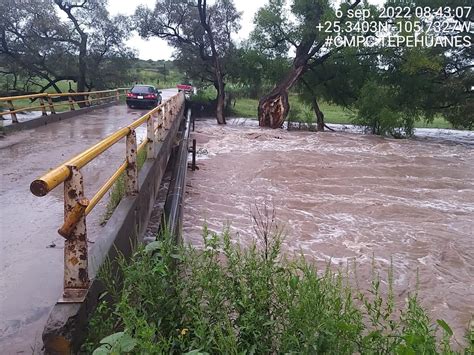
[135,0,240,124]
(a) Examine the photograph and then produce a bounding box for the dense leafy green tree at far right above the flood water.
[355,0,474,136]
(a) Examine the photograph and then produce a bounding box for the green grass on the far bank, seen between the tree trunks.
[232,95,453,129]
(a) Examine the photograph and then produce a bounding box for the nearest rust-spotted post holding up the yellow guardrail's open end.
[59,166,89,303]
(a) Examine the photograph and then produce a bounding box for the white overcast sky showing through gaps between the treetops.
[108,0,384,60]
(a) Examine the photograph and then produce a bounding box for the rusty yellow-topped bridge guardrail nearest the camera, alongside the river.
[26,93,185,303]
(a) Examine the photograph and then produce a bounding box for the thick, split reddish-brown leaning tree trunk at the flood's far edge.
[258,65,306,128]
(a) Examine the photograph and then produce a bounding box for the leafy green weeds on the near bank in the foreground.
[83,227,474,355]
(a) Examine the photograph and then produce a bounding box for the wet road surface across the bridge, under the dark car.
[0,89,176,354]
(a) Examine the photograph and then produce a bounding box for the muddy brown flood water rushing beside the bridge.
[184,120,474,342]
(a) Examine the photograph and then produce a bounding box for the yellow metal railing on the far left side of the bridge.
[0,88,128,123]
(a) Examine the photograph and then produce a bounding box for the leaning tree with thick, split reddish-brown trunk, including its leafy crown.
[253,0,368,128]
